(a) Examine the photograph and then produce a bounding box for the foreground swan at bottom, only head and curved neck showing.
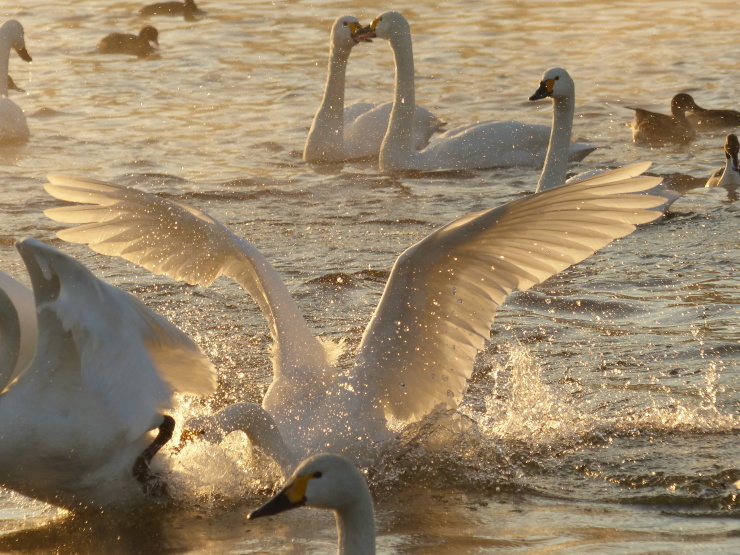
[247,453,375,555]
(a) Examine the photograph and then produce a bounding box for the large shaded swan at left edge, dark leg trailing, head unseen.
[0,238,216,509]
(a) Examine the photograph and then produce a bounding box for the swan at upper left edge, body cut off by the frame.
[0,19,32,143]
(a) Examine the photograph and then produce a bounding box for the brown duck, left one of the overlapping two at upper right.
[627,94,696,146]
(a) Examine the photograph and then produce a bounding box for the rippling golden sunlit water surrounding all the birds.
[0,0,740,554]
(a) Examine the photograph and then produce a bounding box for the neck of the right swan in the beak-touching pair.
[380,33,416,160]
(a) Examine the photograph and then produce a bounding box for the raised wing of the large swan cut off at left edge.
[18,239,216,438]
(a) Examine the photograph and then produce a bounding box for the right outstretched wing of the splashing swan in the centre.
[356,166,665,421]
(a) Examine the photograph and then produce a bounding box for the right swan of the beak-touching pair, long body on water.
[368,12,595,172]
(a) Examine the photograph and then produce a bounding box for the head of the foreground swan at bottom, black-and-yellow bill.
[247,453,372,519]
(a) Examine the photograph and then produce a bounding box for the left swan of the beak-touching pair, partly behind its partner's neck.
[303,16,444,163]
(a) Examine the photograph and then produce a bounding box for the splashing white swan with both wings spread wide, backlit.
[46,167,664,466]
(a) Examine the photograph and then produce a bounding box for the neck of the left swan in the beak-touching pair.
[303,52,349,162]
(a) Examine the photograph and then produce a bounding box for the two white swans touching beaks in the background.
[304,12,595,171]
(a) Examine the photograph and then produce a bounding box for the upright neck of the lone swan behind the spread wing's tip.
[536,95,576,192]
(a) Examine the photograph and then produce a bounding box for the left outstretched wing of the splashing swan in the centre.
[45,175,327,375]
